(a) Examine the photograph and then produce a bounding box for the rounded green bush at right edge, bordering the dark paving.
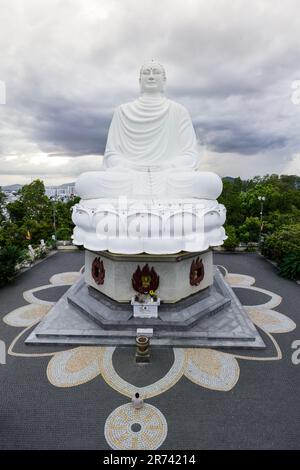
[262,223,300,264]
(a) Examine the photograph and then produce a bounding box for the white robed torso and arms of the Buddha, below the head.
[103,96,198,171]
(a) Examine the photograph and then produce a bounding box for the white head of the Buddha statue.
[140,60,166,94]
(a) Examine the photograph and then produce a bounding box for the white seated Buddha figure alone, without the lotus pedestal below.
[76,61,222,199]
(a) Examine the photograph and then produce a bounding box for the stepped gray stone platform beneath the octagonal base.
[25,268,265,348]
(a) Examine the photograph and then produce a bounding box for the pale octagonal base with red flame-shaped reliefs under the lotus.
[84,250,213,303]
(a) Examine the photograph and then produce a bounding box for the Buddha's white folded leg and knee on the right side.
[167,171,223,199]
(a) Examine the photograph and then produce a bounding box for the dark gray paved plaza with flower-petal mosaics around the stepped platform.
[0,252,300,450]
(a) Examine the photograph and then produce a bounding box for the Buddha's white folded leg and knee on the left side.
[75,171,134,199]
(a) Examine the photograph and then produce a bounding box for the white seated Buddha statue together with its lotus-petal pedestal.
[73,61,226,254]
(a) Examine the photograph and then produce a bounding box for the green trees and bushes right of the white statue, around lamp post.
[219,175,300,279]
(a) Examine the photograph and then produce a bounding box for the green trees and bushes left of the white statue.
[0,180,79,285]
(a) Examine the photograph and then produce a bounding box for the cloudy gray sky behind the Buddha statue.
[0,0,300,185]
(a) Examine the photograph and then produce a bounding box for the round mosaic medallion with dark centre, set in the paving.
[104,403,168,450]
